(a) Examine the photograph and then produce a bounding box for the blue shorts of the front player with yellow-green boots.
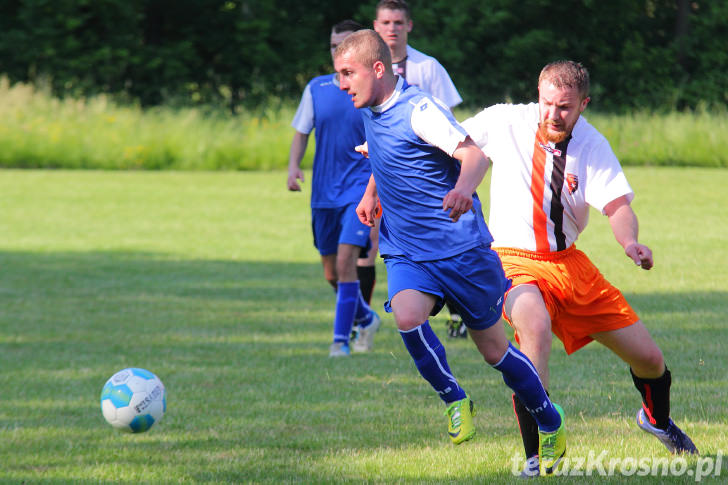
[384,245,511,330]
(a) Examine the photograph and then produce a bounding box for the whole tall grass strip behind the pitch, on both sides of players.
[0,79,728,170]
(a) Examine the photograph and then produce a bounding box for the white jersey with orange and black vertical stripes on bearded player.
[461,103,634,252]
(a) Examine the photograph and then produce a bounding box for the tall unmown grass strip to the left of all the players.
[0,79,313,170]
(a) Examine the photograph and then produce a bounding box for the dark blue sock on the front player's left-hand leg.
[399,320,465,403]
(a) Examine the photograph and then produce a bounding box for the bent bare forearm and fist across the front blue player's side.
[442,136,489,222]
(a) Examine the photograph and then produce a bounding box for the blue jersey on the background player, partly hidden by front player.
[294,74,371,209]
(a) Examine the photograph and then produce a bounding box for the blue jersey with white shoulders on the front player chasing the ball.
[360,80,493,261]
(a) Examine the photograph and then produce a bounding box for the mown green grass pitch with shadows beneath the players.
[0,168,728,484]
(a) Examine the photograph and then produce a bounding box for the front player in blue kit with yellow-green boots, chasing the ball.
[334,30,566,474]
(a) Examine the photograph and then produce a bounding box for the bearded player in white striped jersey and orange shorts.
[462,61,697,475]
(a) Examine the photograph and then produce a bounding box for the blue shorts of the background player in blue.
[311,203,372,257]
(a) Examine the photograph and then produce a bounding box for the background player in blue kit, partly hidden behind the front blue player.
[288,20,380,357]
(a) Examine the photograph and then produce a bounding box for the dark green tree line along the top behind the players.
[0,0,728,112]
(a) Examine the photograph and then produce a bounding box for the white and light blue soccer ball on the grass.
[101,367,167,433]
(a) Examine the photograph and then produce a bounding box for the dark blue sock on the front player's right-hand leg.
[493,342,561,432]
